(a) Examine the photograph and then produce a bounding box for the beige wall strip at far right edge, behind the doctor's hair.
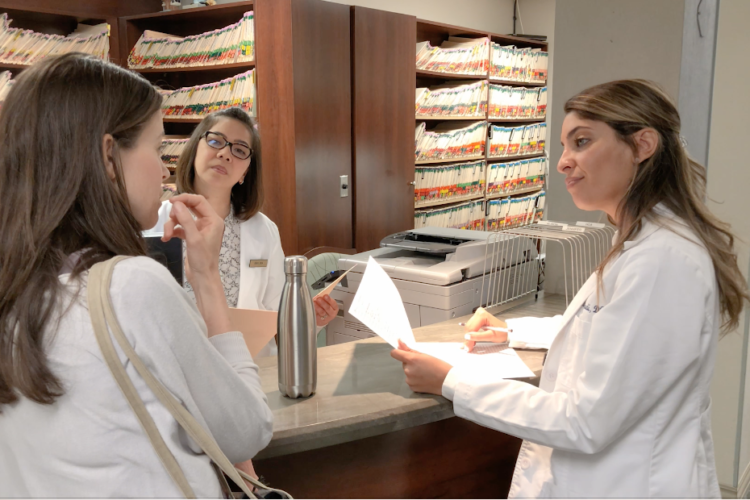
[708,0,750,487]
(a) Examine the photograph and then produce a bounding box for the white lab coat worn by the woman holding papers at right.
[443,206,721,498]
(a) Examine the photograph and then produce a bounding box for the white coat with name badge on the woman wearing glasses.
[144,200,286,358]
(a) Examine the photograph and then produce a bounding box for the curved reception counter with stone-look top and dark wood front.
[254,296,565,498]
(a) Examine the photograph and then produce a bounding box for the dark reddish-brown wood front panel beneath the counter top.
[254,417,521,498]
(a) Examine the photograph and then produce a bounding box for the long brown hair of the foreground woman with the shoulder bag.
[0,54,161,410]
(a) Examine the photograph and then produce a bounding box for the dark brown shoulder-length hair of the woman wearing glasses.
[175,108,263,221]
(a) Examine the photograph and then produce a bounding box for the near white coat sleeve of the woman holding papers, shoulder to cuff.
[443,248,712,453]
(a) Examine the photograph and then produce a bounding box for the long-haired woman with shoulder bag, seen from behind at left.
[0,54,272,498]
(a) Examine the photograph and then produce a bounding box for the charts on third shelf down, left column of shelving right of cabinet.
[414,122,487,162]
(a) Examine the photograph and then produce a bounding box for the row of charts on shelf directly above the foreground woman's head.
[0,12,109,66]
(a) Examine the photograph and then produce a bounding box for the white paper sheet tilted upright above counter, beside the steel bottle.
[349,257,416,348]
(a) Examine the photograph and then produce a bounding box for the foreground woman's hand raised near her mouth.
[162,194,224,288]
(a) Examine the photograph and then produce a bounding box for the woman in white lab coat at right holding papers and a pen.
[392,80,748,498]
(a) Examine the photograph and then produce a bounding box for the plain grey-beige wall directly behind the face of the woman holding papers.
[544,0,684,292]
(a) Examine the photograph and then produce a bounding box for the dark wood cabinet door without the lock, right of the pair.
[352,7,416,252]
